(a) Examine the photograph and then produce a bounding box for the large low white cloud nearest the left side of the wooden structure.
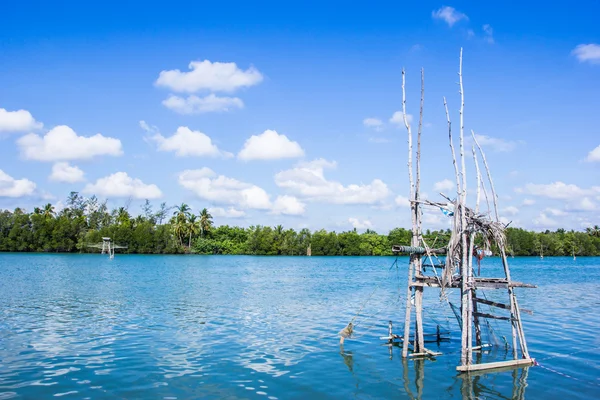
[275,159,390,204]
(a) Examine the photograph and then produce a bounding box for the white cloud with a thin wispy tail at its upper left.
[140,121,233,158]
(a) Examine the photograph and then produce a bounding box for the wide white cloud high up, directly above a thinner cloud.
[156,60,263,93]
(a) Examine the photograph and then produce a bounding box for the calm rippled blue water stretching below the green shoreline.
[0,254,600,399]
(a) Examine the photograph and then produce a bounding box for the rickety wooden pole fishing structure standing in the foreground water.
[389,49,535,372]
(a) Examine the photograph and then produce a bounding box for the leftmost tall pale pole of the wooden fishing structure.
[402,69,418,357]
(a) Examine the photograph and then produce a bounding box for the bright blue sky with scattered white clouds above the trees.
[0,1,600,232]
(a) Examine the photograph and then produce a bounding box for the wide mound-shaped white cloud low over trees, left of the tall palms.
[83,172,162,199]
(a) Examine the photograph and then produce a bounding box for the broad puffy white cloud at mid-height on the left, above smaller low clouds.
[17,125,123,161]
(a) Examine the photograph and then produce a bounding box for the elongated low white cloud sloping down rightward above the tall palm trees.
[178,167,271,210]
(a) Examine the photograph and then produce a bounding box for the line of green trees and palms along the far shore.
[0,192,600,256]
